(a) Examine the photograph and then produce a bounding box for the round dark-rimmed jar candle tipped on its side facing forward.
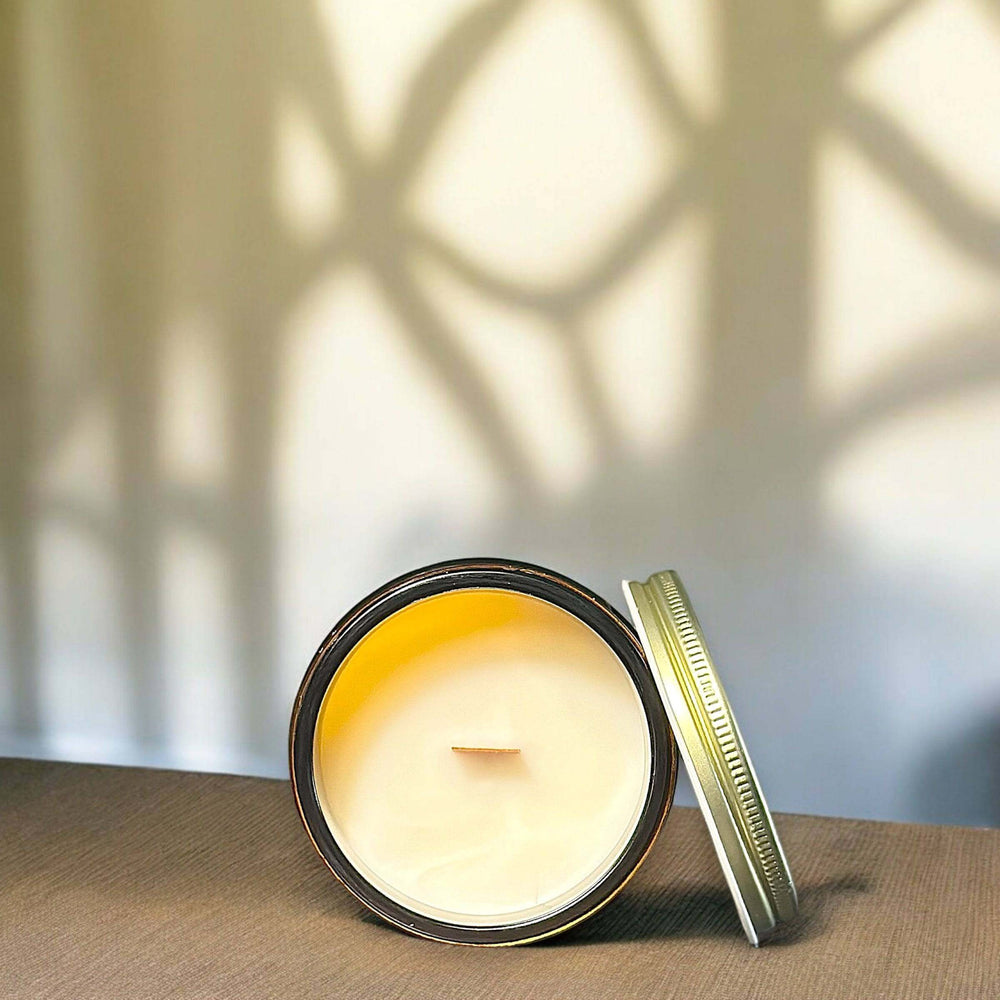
[292,563,675,943]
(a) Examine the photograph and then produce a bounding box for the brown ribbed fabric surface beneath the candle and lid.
[0,760,1000,1000]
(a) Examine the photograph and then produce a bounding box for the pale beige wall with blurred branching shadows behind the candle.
[0,0,1000,823]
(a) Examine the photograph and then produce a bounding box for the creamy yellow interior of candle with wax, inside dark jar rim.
[314,590,650,926]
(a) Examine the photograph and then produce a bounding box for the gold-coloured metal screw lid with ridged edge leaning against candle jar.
[622,570,798,945]
